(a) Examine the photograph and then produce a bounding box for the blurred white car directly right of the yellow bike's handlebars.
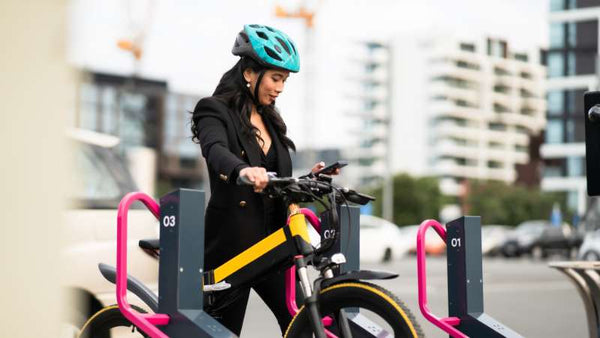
[360,215,414,262]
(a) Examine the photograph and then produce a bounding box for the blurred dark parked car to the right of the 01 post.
[502,220,583,259]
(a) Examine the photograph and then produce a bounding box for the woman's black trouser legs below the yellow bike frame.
[207,271,302,336]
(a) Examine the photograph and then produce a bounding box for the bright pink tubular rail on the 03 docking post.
[116,192,169,338]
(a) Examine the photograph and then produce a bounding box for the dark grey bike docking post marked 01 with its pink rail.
[417,216,522,338]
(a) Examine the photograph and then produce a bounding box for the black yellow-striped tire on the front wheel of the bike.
[284,281,424,338]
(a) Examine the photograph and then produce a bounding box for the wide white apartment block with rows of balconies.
[391,36,546,196]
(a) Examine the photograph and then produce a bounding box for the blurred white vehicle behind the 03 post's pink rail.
[61,130,159,337]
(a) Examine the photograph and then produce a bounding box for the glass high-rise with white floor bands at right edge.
[541,0,600,215]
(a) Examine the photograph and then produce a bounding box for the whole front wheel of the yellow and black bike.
[285,281,424,338]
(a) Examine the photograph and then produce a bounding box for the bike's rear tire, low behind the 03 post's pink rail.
[77,305,148,338]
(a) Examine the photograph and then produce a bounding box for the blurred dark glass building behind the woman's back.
[75,71,203,195]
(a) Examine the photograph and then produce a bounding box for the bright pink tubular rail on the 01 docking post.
[417,220,468,338]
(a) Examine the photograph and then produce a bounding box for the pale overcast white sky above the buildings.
[68,0,548,148]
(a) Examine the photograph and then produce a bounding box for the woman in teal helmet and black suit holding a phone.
[192,25,332,336]
